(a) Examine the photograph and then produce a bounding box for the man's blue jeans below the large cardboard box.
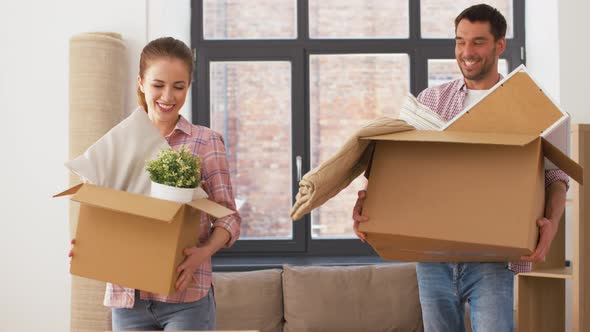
[416,263,514,332]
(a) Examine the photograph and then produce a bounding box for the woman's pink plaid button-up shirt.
[104,116,241,308]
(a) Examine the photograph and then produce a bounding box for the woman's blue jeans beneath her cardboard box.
[112,288,215,331]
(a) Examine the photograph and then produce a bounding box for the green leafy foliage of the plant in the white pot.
[146,145,201,188]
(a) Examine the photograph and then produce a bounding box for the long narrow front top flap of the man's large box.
[364,130,538,146]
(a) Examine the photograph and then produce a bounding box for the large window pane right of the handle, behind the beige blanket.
[309,53,410,239]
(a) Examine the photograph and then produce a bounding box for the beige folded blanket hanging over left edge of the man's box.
[291,117,414,220]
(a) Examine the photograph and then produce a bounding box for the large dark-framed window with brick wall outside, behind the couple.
[191,0,525,259]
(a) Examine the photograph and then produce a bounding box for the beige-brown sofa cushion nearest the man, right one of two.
[283,264,423,332]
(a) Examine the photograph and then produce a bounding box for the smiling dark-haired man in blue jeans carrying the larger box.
[353,4,568,332]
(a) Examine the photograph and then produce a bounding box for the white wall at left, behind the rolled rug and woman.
[0,0,190,332]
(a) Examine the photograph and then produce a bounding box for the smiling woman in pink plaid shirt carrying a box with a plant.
[70,37,241,331]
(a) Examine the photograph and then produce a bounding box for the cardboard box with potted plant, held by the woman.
[54,184,234,295]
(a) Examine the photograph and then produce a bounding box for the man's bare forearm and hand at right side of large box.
[521,181,567,262]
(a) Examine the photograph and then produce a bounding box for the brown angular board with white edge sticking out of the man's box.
[444,67,566,135]
